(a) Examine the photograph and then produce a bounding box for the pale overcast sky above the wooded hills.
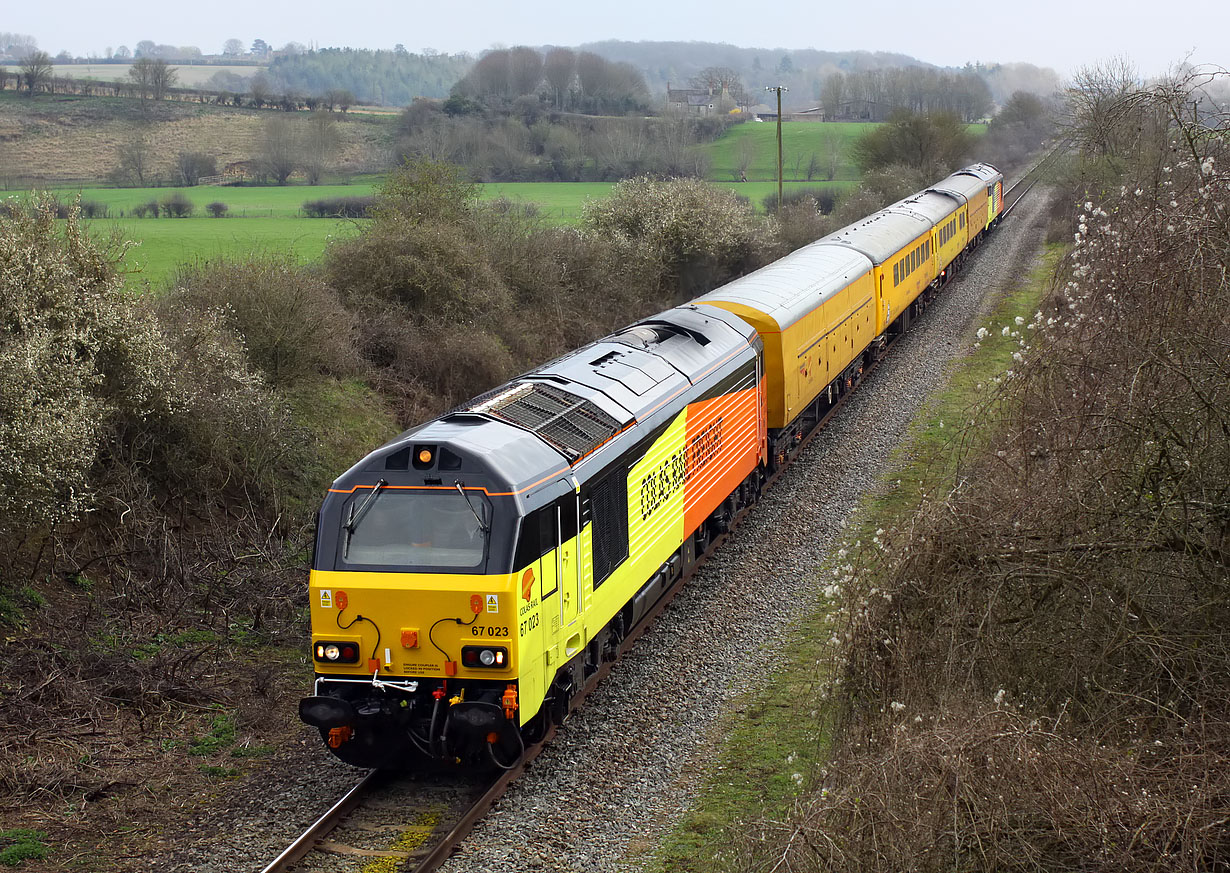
[0,0,1230,76]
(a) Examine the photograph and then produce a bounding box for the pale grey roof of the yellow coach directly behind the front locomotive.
[696,242,871,330]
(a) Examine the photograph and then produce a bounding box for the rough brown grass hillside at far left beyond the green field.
[0,91,391,189]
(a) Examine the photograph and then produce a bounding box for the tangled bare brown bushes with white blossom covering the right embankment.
[703,138,1230,871]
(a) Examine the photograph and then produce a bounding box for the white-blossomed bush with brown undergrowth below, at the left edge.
[0,200,327,797]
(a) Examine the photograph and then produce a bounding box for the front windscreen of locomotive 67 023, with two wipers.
[342,488,491,571]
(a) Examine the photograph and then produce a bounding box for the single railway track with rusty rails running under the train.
[254,150,1052,873]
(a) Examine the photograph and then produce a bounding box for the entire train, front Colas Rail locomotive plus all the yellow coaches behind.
[299,164,1004,767]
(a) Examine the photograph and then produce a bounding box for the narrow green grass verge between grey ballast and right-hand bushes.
[649,246,1064,873]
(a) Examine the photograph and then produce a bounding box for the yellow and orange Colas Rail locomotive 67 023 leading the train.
[300,306,764,767]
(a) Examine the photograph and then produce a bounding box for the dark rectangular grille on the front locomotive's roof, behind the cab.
[456,381,619,460]
